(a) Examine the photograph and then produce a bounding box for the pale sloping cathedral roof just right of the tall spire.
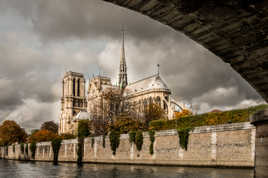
[125,75,170,95]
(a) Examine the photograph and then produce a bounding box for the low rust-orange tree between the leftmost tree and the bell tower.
[29,130,58,142]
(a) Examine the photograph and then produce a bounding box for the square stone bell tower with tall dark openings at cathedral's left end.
[59,71,87,134]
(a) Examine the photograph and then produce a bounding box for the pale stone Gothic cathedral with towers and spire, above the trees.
[59,33,184,134]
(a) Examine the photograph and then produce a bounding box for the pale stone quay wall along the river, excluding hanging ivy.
[0,122,256,167]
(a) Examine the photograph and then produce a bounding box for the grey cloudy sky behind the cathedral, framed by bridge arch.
[0,0,264,128]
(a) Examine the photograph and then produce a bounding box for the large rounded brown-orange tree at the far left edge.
[0,120,27,145]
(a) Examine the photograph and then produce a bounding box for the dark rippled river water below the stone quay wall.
[0,160,254,178]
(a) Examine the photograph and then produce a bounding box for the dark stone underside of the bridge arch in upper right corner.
[103,0,268,101]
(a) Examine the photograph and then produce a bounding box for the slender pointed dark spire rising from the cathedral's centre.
[118,29,128,89]
